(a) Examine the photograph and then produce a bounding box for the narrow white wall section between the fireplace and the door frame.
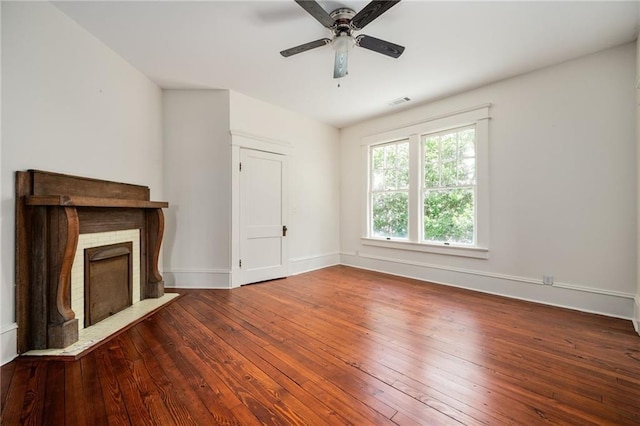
[163,90,231,288]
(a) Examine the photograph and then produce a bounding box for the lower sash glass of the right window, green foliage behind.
[424,188,474,244]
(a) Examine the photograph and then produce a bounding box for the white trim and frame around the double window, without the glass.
[360,104,491,259]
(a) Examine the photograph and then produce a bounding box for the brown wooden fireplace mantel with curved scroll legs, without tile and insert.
[16,170,169,353]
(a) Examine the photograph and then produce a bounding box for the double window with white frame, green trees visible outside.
[363,105,489,258]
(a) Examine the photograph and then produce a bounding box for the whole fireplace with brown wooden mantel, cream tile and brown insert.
[16,170,168,353]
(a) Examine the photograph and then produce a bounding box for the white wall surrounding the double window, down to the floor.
[341,43,638,318]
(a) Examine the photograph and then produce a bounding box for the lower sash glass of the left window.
[372,192,409,238]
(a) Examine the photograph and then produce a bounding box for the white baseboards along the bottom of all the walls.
[161,252,640,324]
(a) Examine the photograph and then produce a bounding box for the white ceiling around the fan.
[54,0,639,128]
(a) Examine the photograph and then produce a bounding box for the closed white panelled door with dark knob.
[240,148,288,284]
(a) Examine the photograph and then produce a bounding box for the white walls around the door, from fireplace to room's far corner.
[163,90,340,288]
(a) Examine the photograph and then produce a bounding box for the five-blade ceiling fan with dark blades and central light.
[280,0,404,78]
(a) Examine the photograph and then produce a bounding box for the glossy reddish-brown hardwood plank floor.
[0,266,640,425]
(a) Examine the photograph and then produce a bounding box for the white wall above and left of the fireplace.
[0,2,163,363]
